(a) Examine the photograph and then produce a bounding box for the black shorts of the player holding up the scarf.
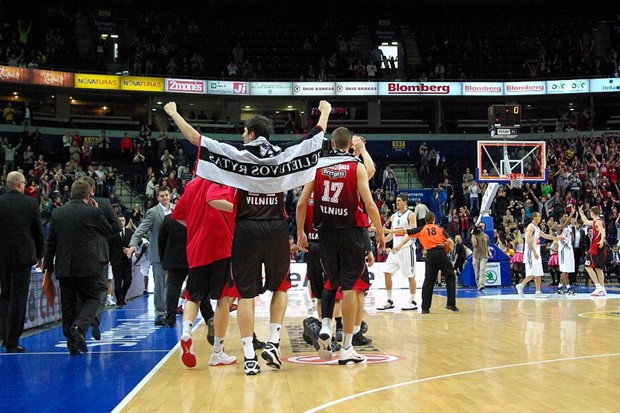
[231,220,291,298]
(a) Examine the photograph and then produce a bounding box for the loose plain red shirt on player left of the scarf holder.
[172,178,234,268]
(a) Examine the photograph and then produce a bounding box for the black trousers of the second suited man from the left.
[58,277,100,350]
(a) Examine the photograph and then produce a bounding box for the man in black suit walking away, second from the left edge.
[44,180,113,355]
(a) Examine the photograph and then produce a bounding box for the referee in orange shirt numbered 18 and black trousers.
[390,211,459,314]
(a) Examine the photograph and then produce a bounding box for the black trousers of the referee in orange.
[422,247,456,310]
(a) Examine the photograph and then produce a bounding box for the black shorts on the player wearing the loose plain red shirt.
[187,258,230,302]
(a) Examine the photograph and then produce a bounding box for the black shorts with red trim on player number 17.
[319,227,370,291]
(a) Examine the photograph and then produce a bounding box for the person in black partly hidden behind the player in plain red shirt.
[158,215,189,327]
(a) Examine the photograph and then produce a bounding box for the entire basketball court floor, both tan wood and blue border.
[0,287,620,412]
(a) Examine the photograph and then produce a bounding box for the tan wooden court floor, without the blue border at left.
[117,289,620,413]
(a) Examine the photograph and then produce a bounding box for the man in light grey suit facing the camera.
[127,187,172,326]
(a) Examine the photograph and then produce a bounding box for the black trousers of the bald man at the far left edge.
[0,265,32,348]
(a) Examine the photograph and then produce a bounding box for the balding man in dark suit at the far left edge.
[0,172,44,353]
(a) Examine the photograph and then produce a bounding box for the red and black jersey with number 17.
[314,161,368,230]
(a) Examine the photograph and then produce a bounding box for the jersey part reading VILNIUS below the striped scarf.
[233,189,287,221]
